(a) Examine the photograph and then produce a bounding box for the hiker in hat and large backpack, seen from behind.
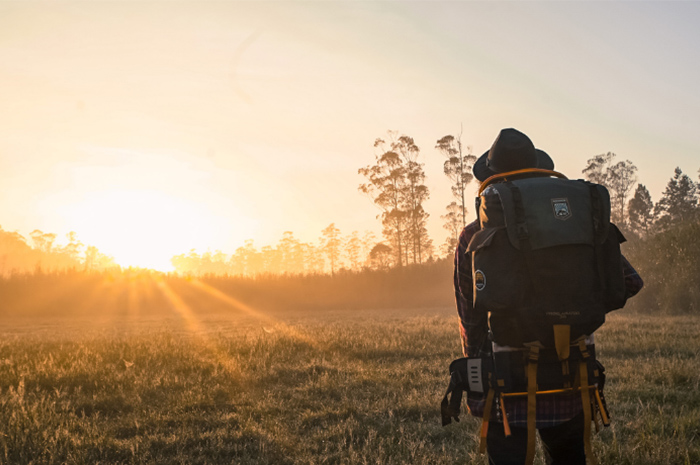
[443,129,642,464]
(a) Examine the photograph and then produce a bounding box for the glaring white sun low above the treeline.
[61,189,225,271]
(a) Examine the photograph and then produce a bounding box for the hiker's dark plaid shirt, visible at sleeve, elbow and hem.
[454,221,644,428]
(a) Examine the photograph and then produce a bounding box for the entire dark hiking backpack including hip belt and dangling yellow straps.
[443,169,625,463]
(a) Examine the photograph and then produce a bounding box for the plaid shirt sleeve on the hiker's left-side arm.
[454,221,488,357]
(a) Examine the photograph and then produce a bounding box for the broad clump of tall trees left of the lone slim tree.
[358,131,430,266]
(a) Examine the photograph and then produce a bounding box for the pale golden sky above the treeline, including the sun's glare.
[0,0,700,268]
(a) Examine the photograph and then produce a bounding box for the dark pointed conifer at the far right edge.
[656,167,698,229]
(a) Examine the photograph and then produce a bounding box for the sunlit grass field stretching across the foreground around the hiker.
[0,308,700,465]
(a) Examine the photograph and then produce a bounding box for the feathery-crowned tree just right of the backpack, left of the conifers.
[582,152,637,225]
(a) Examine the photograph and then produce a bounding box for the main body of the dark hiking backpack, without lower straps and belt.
[467,171,625,347]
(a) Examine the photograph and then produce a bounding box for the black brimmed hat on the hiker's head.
[473,128,554,181]
